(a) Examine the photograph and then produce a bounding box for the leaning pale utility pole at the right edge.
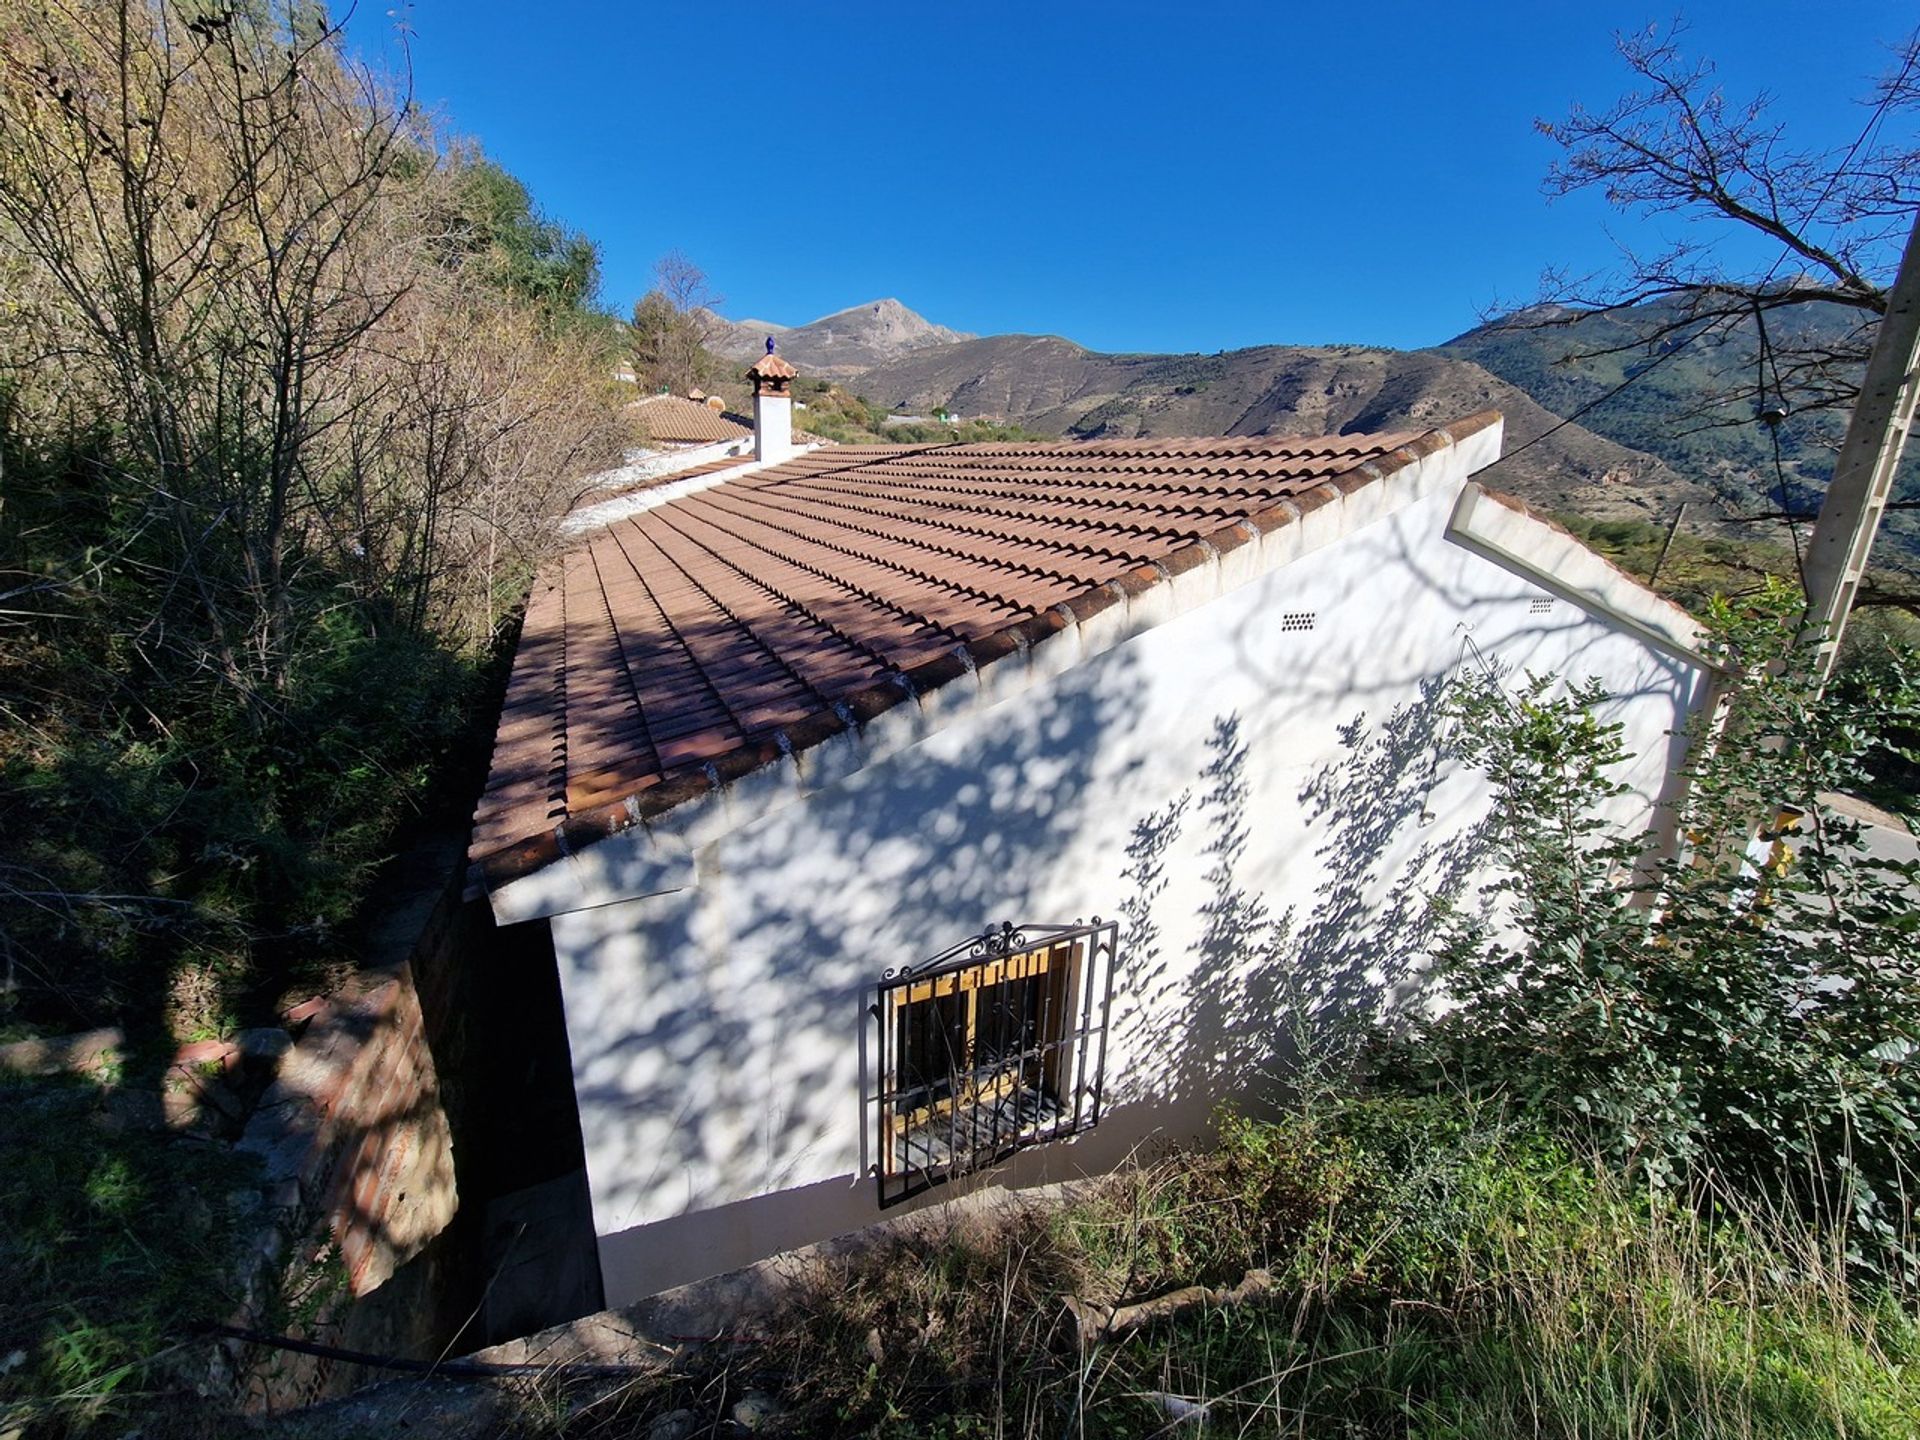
[1801,215,1920,684]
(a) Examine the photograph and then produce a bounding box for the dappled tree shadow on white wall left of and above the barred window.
[566,622,1140,1292]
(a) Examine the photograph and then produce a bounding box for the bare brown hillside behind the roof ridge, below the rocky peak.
[854,336,1713,518]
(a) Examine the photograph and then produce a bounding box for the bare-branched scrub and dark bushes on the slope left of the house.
[0,0,624,1430]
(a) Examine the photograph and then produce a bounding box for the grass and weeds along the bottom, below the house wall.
[480,1098,1920,1440]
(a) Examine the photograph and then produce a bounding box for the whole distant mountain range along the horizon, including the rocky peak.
[716,289,1920,557]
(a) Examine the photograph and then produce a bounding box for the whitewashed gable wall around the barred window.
[553,488,1703,1304]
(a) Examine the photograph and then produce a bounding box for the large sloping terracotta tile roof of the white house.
[470,413,1498,879]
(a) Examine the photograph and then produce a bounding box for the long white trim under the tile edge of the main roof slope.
[488,424,1497,925]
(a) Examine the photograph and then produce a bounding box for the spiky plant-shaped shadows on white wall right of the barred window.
[1116,678,1488,1136]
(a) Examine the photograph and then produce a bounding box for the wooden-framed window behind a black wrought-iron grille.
[870,918,1119,1206]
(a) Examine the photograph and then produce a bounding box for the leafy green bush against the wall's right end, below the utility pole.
[1402,588,1920,1279]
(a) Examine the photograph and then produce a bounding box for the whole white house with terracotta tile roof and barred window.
[472,372,1711,1304]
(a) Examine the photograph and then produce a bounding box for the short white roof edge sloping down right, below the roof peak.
[1446,480,1720,670]
